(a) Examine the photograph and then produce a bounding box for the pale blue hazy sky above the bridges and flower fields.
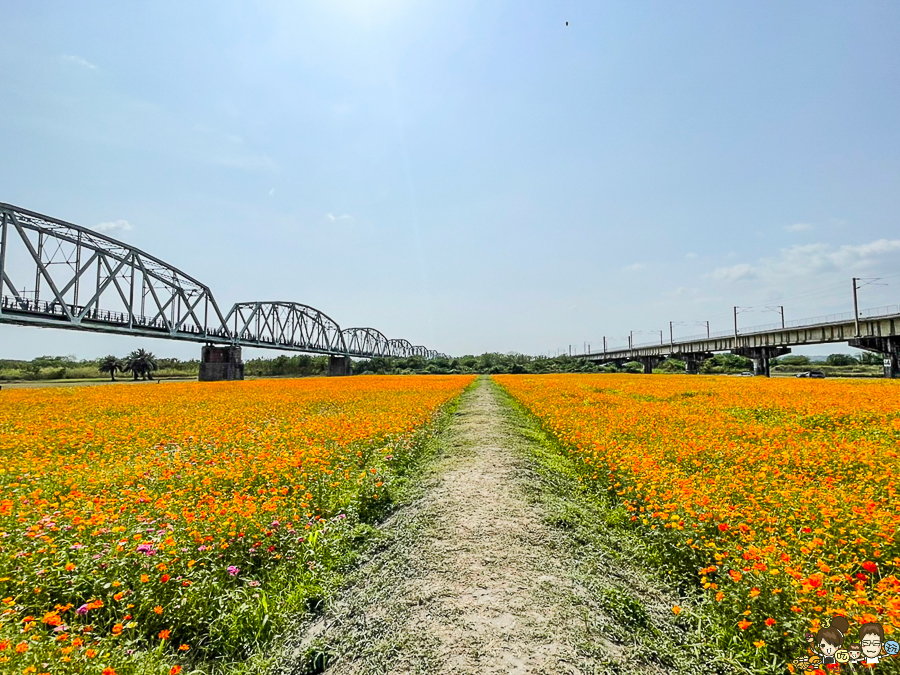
[0,0,900,358]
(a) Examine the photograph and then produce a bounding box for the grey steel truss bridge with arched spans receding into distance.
[0,203,445,359]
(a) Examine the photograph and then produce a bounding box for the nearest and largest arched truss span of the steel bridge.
[0,204,227,339]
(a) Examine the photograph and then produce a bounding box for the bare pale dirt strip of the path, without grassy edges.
[370,374,588,674]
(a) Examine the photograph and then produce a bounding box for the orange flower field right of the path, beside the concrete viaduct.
[494,375,900,672]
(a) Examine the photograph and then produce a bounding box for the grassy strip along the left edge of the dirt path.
[258,384,475,675]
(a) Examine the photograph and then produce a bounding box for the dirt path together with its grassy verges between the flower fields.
[280,379,736,675]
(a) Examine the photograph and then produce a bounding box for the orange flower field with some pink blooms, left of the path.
[0,376,473,675]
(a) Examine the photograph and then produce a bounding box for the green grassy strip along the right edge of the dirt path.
[491,382,752,674]
